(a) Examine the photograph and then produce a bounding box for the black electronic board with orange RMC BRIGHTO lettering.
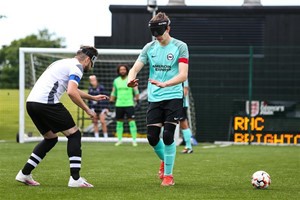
[231,100,300,144]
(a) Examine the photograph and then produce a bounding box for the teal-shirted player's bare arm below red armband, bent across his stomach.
[149,62,189,88]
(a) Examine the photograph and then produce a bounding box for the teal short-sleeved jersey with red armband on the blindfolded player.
[138,38,189,102]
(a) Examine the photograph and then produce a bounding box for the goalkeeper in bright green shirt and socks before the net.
[110,64,139,146]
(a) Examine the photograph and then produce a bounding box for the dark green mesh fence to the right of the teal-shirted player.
[189,46,300,142]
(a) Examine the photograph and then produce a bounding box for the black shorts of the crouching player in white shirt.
[26,102,75,135]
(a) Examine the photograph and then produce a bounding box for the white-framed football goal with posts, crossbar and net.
[18,48,195,143]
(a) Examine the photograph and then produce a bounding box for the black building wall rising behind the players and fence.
[95,6,300,141]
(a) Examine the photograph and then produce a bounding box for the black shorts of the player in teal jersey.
[147,99,183,124]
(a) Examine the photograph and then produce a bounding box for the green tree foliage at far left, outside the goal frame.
[0,29,64,88]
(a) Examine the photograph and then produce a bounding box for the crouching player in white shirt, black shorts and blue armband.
[16,46,108,187]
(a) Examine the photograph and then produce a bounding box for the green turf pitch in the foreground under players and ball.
[0,142,300,200]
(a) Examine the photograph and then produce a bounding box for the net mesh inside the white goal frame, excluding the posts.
[19,49,196,141]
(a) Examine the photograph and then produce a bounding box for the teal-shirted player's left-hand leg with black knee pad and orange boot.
[147,103,165,179]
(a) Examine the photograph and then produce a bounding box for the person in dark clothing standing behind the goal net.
[88,75,109,138]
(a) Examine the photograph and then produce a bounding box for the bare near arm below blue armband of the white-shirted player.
[67,81,96,118]
